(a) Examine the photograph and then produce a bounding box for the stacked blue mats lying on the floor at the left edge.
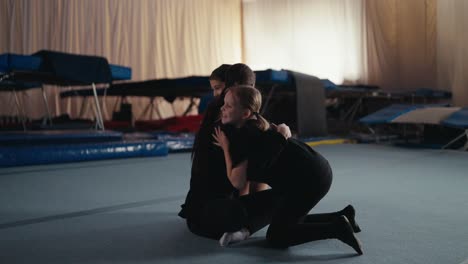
[0,131,168,167]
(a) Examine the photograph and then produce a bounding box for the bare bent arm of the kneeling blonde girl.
[213,127,248,190]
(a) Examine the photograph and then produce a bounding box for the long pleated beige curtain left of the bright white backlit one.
[0,0,242,119]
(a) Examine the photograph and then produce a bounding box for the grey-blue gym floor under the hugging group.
[0,144,468,264]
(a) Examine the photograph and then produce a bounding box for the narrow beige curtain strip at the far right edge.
[437,0,468,107]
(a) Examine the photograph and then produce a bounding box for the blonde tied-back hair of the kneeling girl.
[228,85,270,131]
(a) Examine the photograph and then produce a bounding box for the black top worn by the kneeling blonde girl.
[227,120,332,191]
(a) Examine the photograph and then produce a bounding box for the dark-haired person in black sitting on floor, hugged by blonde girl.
[179,63,291,240]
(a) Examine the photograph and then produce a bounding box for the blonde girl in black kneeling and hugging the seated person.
[213,86,362,255]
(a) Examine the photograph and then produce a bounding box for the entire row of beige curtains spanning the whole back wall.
[0,0,468,119]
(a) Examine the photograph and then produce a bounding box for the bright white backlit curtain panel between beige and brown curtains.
[243,0,366,83]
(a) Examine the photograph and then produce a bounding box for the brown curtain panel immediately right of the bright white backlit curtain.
[366,0,436,90]
